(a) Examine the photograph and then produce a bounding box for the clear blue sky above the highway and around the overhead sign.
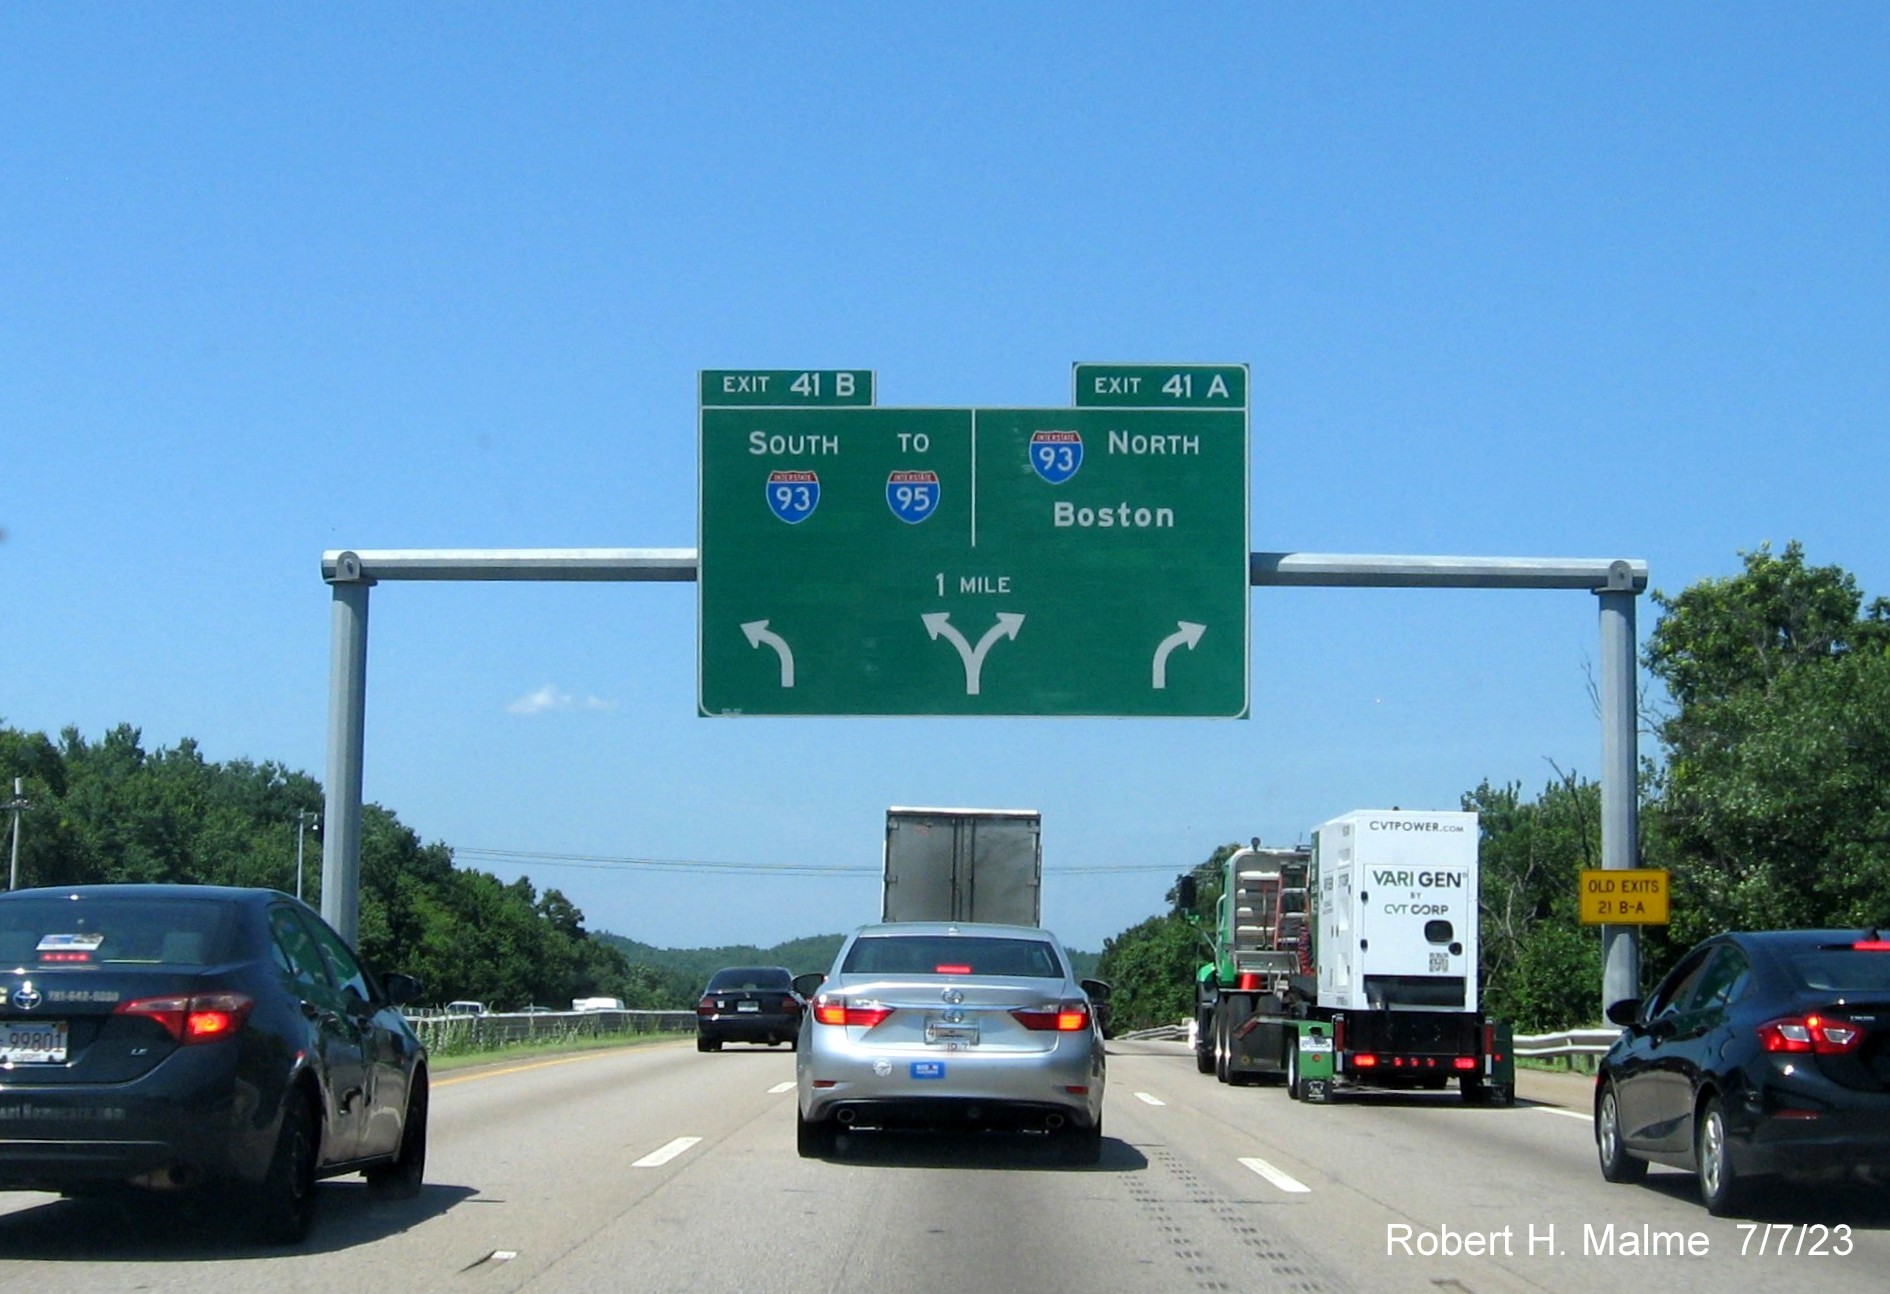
[0,4,1890,948]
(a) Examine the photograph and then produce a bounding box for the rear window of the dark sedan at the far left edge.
[0,897,229,967]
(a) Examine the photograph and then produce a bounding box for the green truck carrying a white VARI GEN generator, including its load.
[1181,809,1516,1105]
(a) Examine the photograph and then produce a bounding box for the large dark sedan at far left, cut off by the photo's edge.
[0,884,427,1245]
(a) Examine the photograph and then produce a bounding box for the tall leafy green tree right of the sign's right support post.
[1644,542,1890,946]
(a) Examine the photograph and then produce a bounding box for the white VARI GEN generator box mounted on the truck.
[1312,809,1478,1011]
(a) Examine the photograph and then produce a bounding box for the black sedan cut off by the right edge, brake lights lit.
[1595,929,1890,1215]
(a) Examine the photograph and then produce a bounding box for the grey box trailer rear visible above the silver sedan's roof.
[881,809,1043,926]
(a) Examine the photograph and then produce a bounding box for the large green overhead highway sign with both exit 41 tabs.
[697,365,1249,718]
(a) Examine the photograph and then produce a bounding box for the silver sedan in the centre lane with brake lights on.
[794,922,1106,1164]
